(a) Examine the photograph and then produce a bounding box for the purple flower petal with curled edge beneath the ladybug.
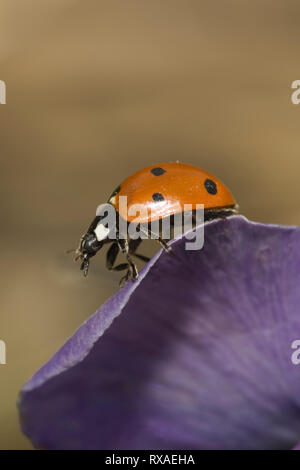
[19,216,300,449]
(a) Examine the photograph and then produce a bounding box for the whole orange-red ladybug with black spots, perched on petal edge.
[75,162,238,285]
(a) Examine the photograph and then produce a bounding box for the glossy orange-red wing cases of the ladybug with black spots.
[108,163,236,223]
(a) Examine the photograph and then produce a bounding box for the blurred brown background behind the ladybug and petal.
[0,0,300,449]
